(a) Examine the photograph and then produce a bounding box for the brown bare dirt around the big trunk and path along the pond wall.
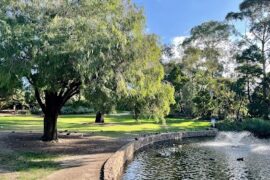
[0,132,130,180]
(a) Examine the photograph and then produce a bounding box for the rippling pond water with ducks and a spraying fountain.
[123,132,270,180]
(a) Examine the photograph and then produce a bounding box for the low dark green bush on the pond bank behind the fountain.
[216,119,270,138]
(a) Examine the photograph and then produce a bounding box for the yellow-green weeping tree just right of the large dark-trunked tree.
[84,3,174,123]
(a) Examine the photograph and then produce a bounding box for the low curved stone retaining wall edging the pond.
[102,130,217,180]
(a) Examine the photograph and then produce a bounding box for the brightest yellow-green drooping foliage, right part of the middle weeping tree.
[118,35,174,121]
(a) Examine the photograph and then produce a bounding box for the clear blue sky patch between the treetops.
[133,0,242,43]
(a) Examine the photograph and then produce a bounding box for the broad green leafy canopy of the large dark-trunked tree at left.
[0,0,144,103]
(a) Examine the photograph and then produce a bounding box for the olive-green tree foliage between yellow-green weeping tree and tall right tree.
[167,21,235,119]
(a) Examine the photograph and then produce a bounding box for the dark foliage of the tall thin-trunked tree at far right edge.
[226,0,270,119]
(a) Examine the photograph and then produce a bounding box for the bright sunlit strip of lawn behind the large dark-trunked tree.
[0,115,210,137]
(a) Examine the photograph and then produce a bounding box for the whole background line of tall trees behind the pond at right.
[164,0,270,120]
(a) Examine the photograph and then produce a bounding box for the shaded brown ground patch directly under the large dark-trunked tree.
[0,133,129,156]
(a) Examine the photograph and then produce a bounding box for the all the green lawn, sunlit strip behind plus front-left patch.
[0,115,210,180]
